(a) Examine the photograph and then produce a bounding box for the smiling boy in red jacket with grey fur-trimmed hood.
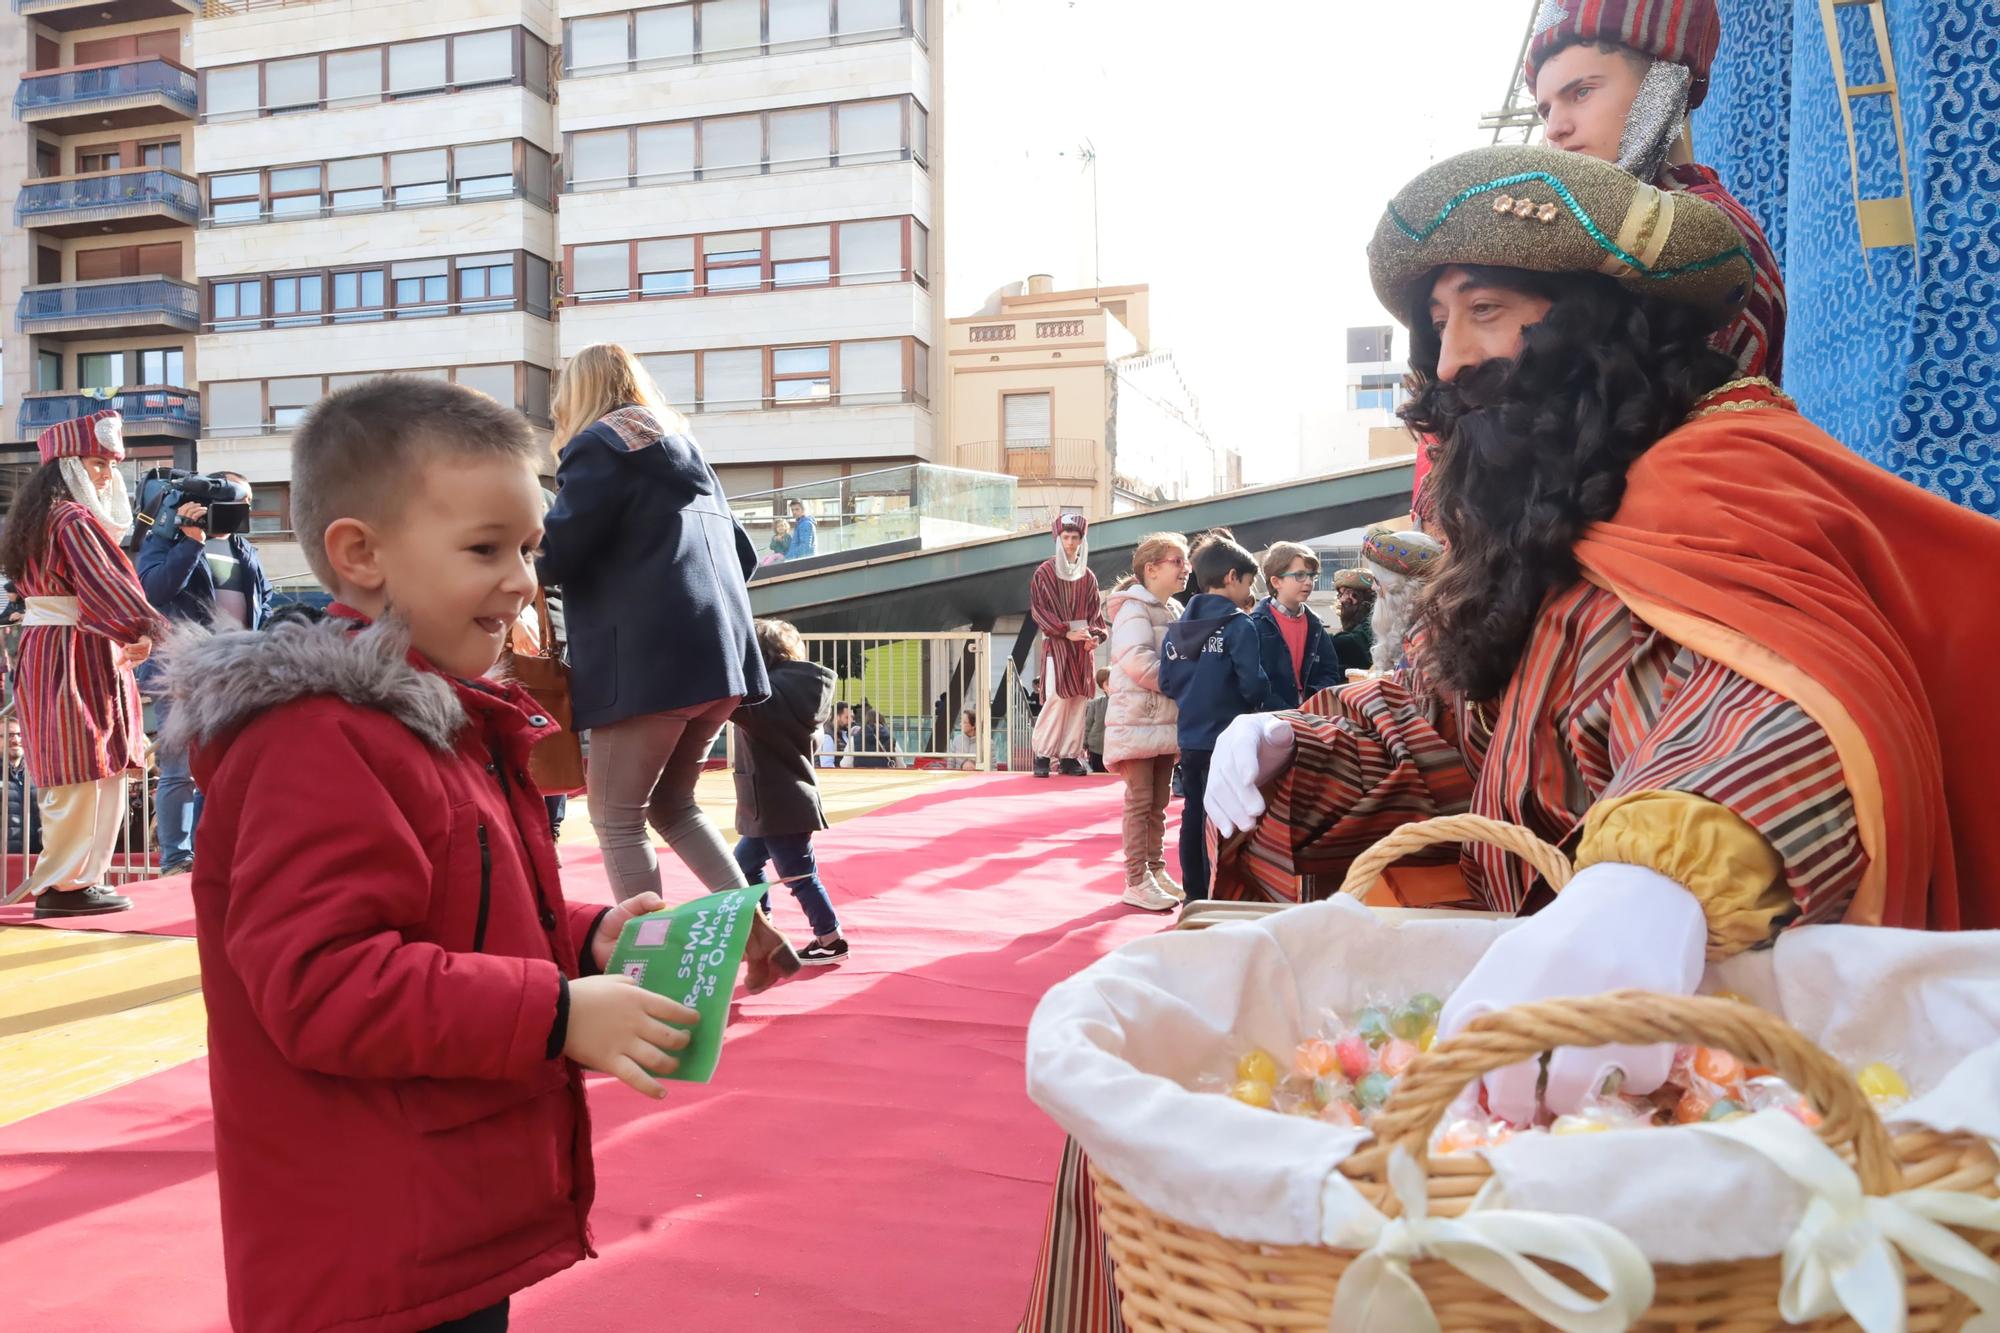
[162,378,696,1333]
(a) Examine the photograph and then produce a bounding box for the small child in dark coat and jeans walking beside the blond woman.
[730,620,848,965]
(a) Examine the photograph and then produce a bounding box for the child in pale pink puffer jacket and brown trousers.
[1104,532,1188,913]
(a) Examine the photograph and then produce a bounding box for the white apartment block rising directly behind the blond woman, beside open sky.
[558,0,944,500]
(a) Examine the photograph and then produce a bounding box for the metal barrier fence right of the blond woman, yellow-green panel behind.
[724,632,998,773]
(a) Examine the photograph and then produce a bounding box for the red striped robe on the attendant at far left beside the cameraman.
[14,500,160,789]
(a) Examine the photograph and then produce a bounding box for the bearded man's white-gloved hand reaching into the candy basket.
[1440,860,1708,1125]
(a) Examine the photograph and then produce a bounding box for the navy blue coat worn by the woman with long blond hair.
[542,408,770,731]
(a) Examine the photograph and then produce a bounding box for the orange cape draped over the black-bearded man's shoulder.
[1576,384,2000,931]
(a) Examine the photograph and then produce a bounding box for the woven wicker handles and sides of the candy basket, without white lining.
[1090,815,2000,1333]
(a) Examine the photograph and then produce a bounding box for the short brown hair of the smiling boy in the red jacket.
[292,374,542,592]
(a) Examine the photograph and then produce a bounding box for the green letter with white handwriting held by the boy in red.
[604,885,768,1083]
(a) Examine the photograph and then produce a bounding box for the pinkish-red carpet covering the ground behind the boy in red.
[0,775,1164,1333]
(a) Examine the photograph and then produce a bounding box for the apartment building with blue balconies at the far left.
[0,0,200,500]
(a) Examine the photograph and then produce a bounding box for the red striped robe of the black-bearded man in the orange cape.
[1216,582,1866,923]
